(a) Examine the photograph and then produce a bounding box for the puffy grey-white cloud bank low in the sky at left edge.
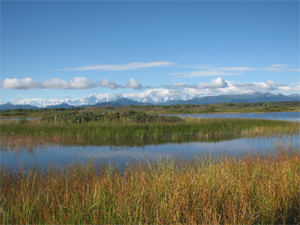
[1,77,97,90]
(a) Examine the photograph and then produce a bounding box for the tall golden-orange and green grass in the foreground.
[0,149,300,224]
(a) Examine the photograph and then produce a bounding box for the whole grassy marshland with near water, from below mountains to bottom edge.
[0,102,300,224]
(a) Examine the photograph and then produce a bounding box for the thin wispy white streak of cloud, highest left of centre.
[61,61,174,71]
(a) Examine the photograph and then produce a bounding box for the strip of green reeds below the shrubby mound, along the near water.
[1,118,299,140]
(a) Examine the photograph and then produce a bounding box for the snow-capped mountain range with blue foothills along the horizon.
[1,89,300,110]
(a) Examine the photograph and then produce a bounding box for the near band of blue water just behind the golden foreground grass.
[1,135,300,168]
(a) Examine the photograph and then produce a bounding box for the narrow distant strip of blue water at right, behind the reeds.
[168,112,300,121]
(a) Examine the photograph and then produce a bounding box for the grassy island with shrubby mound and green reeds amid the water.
[1,111,299,149]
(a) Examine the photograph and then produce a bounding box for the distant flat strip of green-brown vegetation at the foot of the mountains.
[1,101,300,119]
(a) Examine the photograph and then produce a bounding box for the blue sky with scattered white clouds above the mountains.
[0,1,300,103]
